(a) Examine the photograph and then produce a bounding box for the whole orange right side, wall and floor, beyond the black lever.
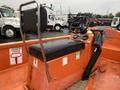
[85,29,120,90]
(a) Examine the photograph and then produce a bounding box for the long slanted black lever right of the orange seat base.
[83,30,104,80]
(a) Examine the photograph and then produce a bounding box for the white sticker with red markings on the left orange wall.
[9,48,23,65]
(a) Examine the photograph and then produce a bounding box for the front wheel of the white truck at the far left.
[4,27,17,38]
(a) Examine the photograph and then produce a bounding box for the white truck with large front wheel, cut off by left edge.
[0,7,20,38]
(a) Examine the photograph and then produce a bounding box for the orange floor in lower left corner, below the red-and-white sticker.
[0,64,28,90]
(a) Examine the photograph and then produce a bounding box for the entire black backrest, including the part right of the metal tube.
[21,7,47,33]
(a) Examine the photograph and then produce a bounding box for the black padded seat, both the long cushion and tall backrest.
[21,3,85,61]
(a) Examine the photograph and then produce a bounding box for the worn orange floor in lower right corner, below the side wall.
[85,58,120,90]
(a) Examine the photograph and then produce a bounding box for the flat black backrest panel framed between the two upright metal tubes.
[21,8,38,32]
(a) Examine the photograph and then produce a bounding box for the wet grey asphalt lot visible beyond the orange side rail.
[0,26,109,43]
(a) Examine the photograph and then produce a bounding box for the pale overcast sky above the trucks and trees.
[0,0,120,14]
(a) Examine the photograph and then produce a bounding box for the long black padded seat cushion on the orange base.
[29,39,85,61]
